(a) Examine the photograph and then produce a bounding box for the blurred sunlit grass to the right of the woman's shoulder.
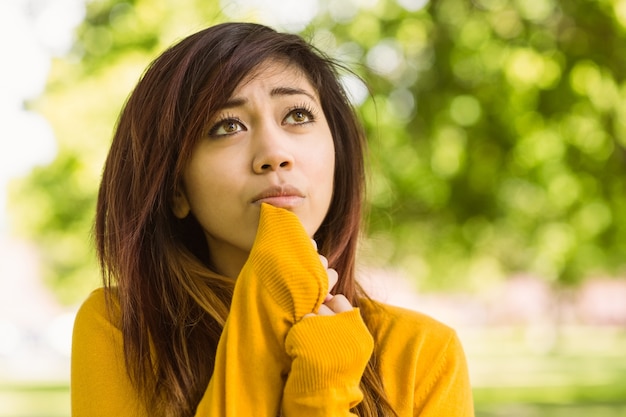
[461,327,626,417]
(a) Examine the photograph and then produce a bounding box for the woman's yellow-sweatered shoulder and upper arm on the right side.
[361,300,472,416]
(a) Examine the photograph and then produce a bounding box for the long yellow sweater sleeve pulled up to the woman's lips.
[196,204,328,417]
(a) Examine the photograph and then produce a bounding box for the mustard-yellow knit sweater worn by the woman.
[71,205,474,417]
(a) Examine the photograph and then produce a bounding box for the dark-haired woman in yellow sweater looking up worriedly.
[72,23,473,417]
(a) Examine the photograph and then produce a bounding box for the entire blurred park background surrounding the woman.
[0,0,626,417]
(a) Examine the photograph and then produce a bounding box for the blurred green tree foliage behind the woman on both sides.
[11,0,626,301]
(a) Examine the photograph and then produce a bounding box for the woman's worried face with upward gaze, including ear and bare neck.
[173,60,335,278]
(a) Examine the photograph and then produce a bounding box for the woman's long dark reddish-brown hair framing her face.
[95,23,394,417]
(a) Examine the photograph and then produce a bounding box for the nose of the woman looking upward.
[252,129,294,174]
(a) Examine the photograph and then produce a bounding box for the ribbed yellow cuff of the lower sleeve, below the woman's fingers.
[285,308,374,393]
